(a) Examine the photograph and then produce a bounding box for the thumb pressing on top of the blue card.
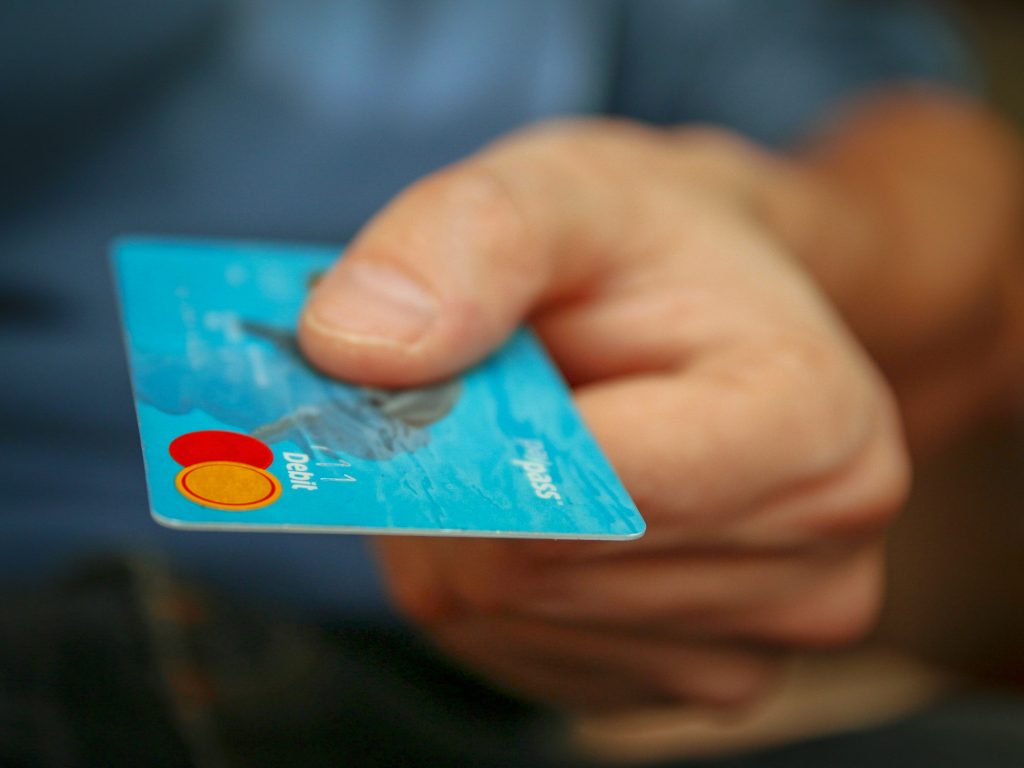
[299,132,626,386]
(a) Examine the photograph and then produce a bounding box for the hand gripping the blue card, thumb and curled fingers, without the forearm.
[300,122,908,710]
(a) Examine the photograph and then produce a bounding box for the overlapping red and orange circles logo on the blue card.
[168,429,281,512]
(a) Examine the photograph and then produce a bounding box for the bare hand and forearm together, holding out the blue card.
[292,88,1024,712]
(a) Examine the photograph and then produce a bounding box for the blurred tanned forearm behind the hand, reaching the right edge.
[760,92,1024,450]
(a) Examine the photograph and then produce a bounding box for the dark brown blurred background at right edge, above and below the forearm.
[882,0,1024,683]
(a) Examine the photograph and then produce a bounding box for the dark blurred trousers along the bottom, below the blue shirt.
[0,560,1024,768]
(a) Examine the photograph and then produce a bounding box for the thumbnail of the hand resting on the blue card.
[306,262,437,345]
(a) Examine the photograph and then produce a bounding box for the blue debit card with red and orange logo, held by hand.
[113,238,644,539]
